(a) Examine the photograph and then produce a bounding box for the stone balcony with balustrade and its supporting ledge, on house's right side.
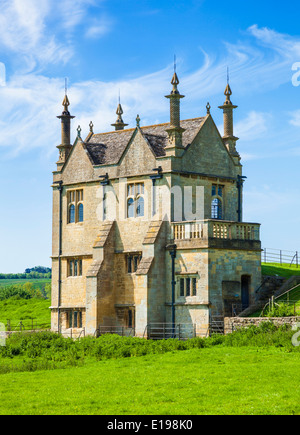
[171,219,261,250]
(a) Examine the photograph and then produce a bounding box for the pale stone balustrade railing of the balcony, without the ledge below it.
[172,220,260,241]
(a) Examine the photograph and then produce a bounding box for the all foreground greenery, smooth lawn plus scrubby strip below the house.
[0,323,300,415]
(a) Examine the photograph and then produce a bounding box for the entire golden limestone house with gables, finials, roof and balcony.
[51,73,261,337]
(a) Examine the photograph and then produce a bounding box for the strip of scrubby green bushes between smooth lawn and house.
[0,322,299,373]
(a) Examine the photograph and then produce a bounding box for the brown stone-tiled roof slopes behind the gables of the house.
[84,118,205,166]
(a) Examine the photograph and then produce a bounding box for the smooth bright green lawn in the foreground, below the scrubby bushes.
[0,346,300,415]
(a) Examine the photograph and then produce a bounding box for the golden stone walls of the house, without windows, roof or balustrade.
[52,108,261,336]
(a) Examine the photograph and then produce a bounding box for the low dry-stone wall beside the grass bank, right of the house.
[224,317,300,334]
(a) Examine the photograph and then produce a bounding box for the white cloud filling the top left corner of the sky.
[0,0,111,72]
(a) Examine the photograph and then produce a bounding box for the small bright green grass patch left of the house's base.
[0,299,51,330]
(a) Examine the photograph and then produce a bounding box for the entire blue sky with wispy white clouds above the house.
[0,0,300,272]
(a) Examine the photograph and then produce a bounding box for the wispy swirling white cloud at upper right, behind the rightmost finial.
[182,25,300,102]
